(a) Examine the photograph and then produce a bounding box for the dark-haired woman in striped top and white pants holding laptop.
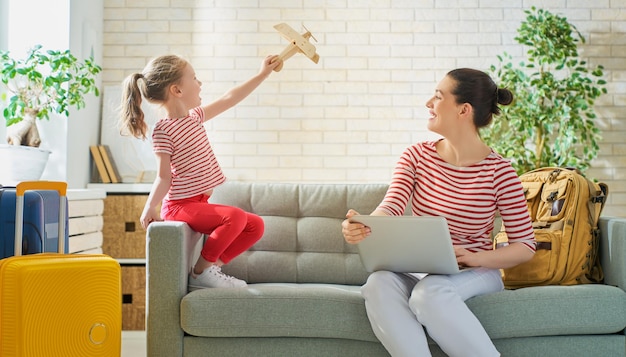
[342,68,535,357]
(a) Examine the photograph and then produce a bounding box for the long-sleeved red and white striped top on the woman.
[378,141,535,252]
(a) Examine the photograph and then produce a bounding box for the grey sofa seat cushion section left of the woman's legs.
[181,284,377,342]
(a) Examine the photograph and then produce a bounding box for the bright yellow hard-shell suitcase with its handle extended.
[0,181,122,357]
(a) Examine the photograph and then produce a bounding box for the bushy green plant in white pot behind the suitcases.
[0,45,102,183]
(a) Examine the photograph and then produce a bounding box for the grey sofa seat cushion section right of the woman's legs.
[467,284,626,339]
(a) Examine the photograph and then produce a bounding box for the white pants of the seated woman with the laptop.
[361,268,504,357]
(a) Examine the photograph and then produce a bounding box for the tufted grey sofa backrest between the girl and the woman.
[211,181,387,285]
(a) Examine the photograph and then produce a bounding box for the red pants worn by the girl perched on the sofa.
[161,195,265,264]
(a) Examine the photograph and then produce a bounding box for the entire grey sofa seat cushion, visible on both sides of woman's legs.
[181,284,626,341]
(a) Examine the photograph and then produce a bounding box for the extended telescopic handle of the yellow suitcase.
[14,181,67,257]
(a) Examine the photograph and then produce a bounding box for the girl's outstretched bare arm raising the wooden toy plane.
[202,55,281,121]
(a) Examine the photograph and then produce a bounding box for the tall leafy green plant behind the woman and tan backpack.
[481,7,607,174]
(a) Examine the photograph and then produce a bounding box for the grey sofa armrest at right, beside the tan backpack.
[599,217,626,291]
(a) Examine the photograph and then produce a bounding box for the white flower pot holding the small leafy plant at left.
[0,145,50,186]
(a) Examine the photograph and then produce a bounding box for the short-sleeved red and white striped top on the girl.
[152,107,226,200]
